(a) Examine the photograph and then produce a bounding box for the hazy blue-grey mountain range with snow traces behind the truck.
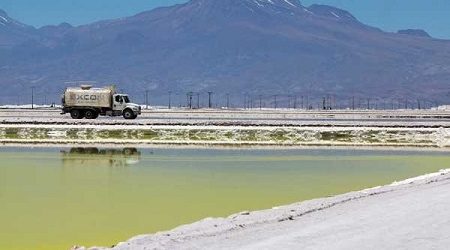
[0,0,450,104]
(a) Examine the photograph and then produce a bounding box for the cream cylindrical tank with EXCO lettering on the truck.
[64,86,115,108]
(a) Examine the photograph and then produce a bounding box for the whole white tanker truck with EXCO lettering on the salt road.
[61,85,141,119]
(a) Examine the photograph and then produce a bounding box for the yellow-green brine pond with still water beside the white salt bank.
[0,148,450,250]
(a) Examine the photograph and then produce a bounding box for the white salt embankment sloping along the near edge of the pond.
[79,170,450,250]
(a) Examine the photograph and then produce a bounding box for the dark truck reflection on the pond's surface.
[61,148,141,167]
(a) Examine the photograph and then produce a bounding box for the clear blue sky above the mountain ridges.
[0,0,450,39]
